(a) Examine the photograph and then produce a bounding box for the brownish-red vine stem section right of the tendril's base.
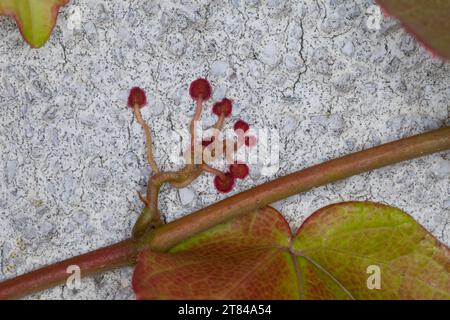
[144,127,450,251]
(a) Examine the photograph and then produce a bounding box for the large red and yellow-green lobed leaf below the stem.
[133,202,450,299]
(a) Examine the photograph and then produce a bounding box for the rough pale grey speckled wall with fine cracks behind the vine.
[0,0,450,299]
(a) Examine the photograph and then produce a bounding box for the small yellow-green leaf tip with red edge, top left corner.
[0,0,69,48]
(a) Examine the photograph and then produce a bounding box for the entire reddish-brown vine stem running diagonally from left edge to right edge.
[0,127,450,299]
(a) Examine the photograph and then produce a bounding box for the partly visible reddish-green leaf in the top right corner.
[377,0,450,59]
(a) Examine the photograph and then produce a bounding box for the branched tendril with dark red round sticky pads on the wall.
[128,79,255,238]
